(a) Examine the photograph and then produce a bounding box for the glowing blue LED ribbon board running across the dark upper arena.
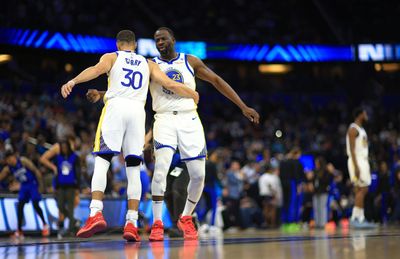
[4,28,400,63]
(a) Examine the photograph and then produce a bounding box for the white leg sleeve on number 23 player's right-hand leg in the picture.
[186,159,206,202]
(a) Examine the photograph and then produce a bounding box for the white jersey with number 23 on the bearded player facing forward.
[150,53,197,113]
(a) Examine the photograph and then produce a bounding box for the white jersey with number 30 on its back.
[105,51,150,102]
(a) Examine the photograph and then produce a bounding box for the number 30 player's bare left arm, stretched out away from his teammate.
[61,53,117,98]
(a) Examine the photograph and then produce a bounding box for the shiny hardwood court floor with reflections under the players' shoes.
[0,227,400,259]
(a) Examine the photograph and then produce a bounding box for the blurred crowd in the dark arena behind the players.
[0,74,400,228]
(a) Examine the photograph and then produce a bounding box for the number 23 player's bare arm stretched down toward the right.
[188,55,260,123]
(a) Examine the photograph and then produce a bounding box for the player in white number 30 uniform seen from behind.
[61,30,198,241]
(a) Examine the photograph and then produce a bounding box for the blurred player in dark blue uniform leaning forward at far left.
[0,150,50,238]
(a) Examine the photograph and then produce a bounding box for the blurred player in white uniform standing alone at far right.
[346,108,375,228]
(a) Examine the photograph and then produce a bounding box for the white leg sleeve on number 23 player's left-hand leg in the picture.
[151,148,174,196]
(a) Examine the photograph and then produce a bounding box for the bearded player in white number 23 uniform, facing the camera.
[149,27,259,241]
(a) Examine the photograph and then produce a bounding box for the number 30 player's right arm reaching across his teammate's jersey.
[148,60,199,104]
